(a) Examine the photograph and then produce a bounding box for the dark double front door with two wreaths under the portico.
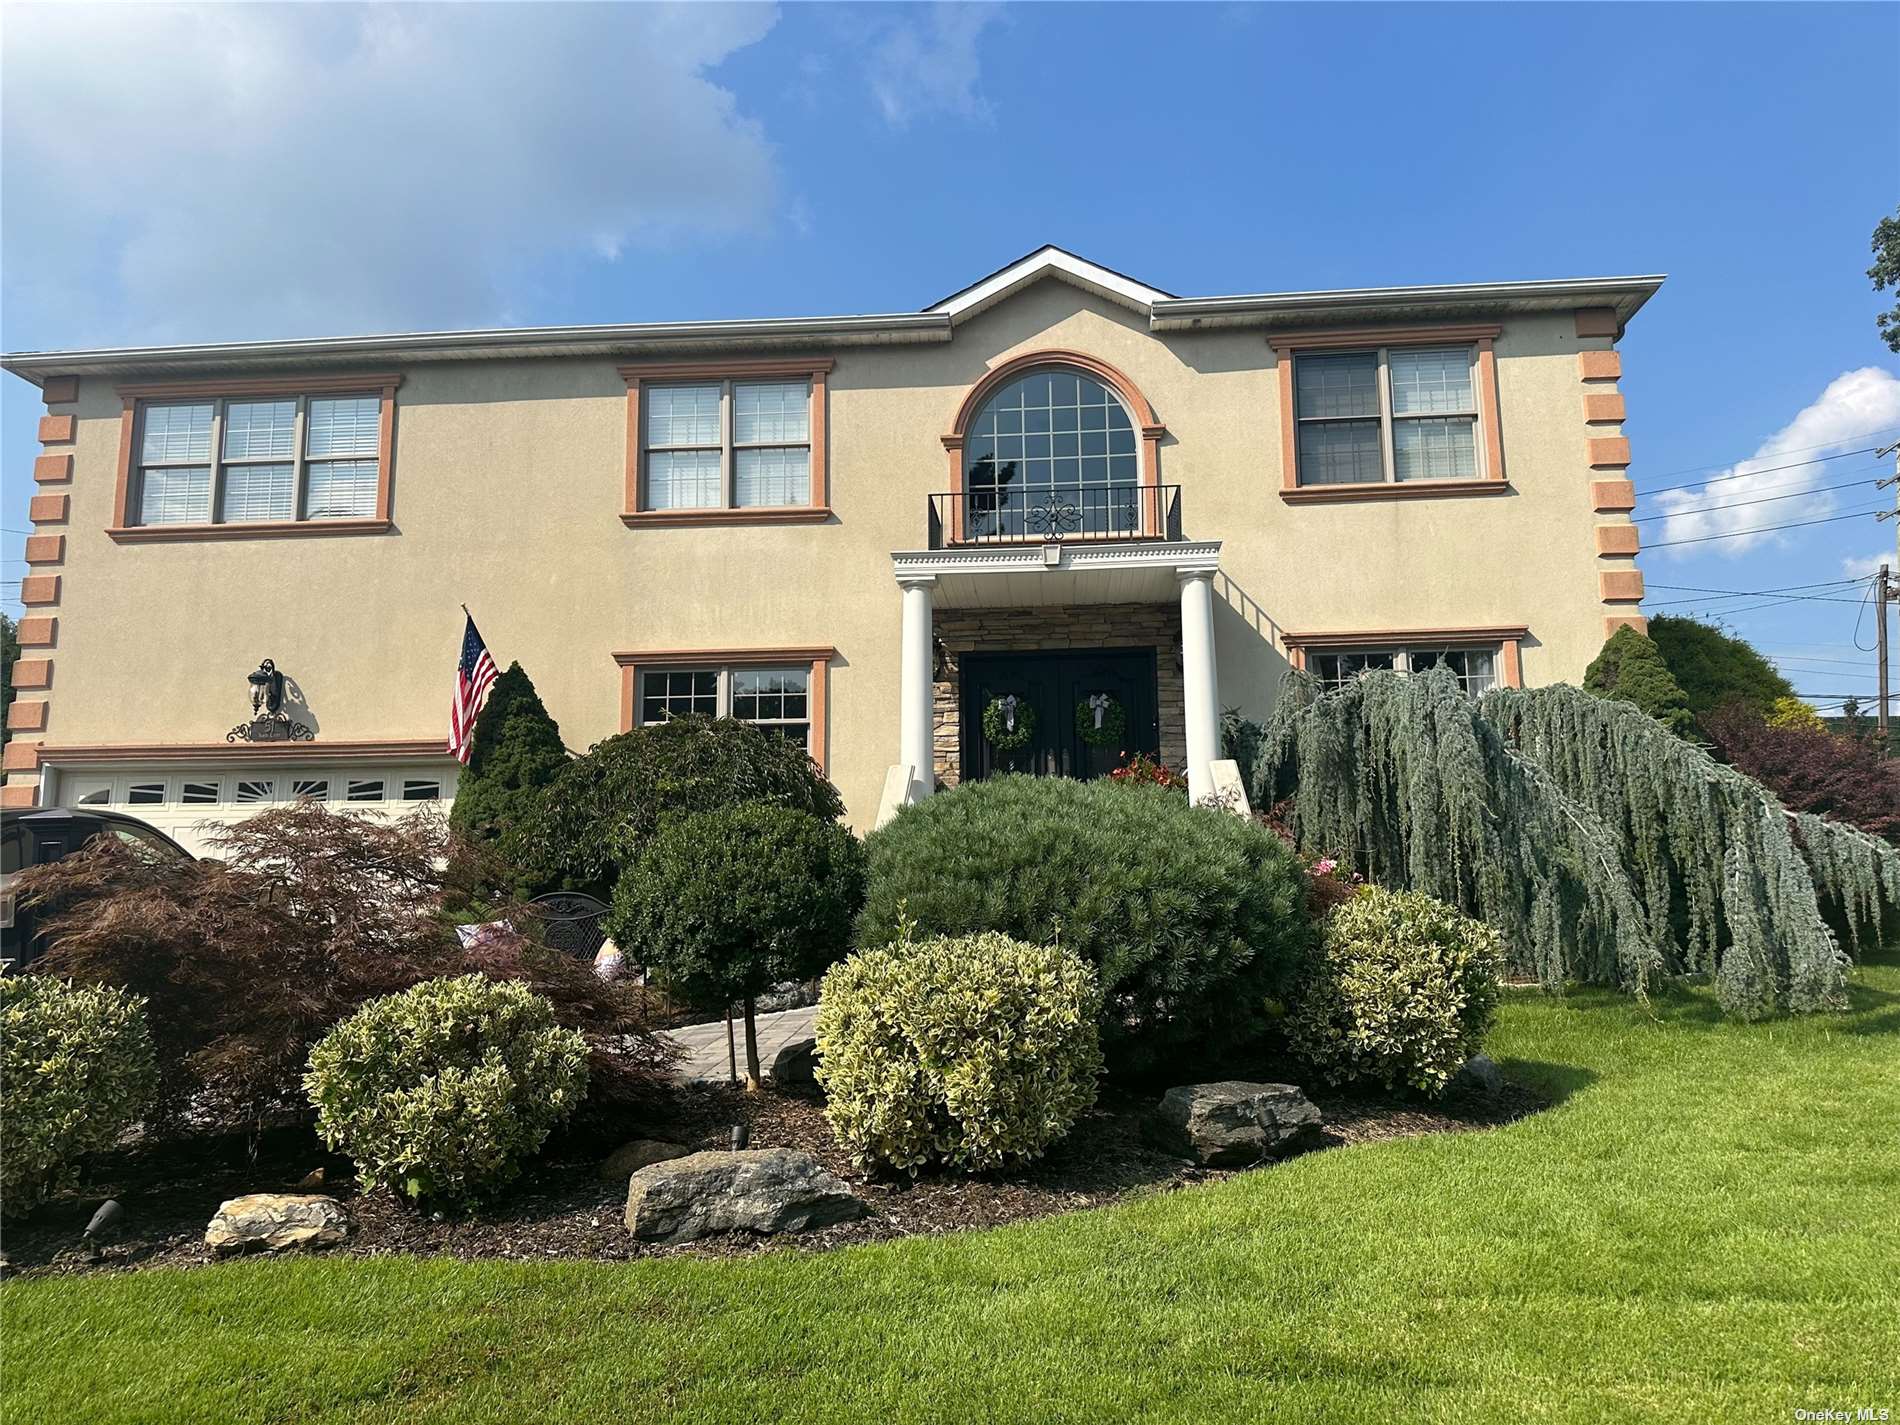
[958,648,1161,781]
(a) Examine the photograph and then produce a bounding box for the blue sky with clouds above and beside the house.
[0,4,1900,710]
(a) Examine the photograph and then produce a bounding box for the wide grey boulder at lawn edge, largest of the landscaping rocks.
[627,1148,865,1243]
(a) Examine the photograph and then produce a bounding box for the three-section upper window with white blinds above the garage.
[114,376,395,534]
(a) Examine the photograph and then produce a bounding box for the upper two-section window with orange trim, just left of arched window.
[621,361,830,524]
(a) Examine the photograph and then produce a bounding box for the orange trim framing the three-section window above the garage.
[106,372,403,543]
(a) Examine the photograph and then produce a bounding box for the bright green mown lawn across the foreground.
[0,967,1900,1425]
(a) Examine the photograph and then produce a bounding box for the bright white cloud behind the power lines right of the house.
[1655,367,1900,557]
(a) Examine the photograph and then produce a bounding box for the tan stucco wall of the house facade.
[14,281,1628,827]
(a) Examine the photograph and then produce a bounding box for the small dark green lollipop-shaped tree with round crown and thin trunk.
[606,804,865,1089]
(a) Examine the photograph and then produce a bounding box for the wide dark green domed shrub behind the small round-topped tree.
[511,718,844,899]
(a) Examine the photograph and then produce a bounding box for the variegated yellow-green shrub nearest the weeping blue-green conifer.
[1286,885,1505,1094]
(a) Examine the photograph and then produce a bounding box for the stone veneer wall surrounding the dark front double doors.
[935,604,1188,787]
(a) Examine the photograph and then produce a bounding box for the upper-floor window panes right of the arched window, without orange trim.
[1294,346,1478,485]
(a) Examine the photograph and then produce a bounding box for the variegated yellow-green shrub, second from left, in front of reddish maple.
[304,975,587,1201]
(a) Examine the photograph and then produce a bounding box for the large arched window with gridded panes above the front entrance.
[963,367,1142,538]
